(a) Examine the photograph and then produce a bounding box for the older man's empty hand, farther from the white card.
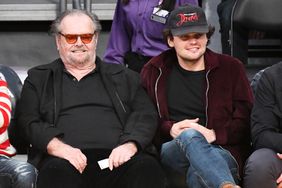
[47,138,87,173]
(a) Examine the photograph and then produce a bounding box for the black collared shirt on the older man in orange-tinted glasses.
[58,65,122,149]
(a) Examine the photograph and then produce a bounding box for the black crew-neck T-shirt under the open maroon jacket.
[167,64,206,126]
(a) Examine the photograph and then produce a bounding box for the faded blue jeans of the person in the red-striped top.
[0,156,37,188]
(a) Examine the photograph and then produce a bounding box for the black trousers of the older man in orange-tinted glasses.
[37,150,166,188]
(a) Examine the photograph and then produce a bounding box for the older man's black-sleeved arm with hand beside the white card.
[109,77,157,170]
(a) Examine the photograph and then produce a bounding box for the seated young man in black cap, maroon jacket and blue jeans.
[141,5,253,188]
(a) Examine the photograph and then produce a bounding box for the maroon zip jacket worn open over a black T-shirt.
[141,49,253,172]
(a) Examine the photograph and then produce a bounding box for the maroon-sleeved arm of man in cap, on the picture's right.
[213,63,253,145]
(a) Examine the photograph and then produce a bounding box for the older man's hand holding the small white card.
[109,142,137,170]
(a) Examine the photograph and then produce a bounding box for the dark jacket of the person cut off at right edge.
[251,62,282,153]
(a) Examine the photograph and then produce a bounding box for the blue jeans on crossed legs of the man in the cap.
[161,129,239,188]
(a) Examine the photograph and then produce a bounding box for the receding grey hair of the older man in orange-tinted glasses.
[50,9,102,35]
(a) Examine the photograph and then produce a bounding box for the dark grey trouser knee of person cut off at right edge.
[243,148,282,188]
